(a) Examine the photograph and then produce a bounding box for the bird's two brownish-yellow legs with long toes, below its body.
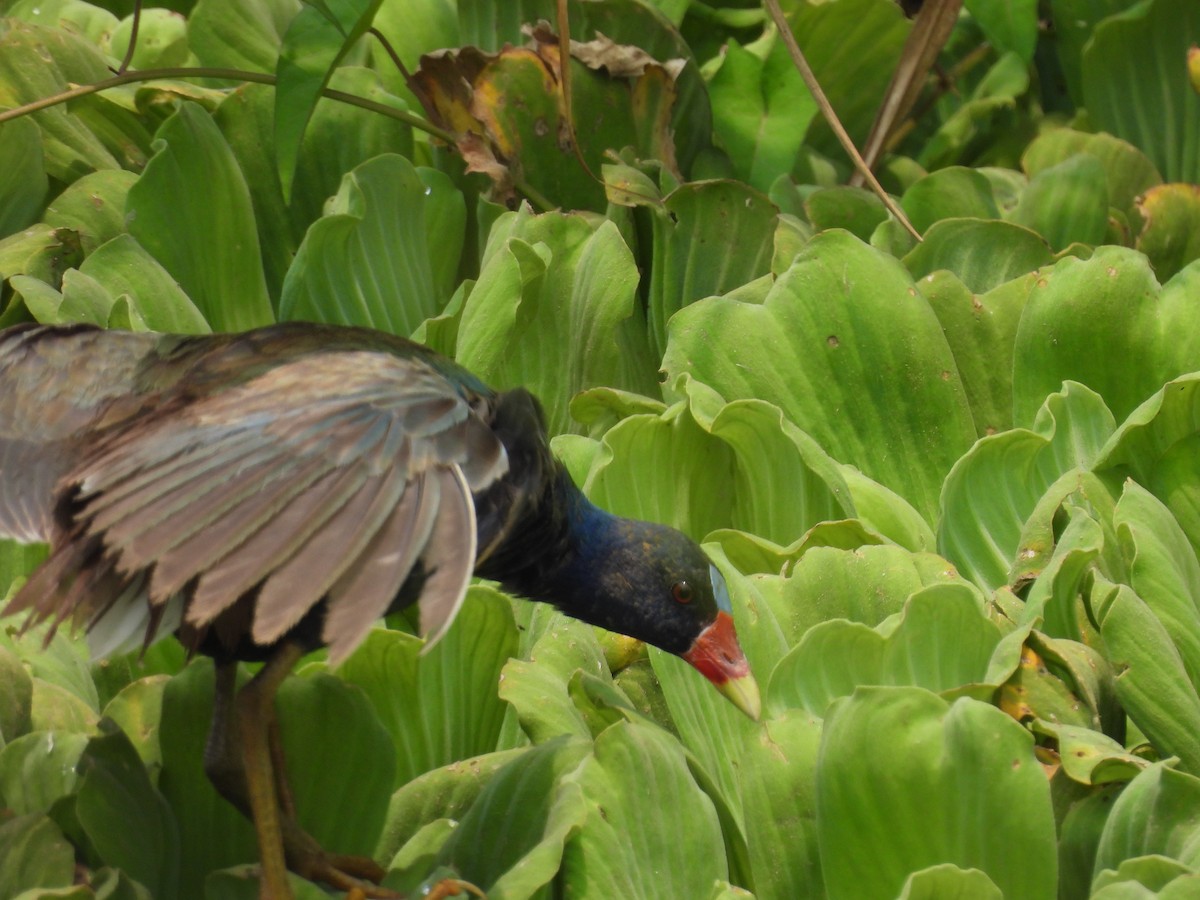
[204,644,400,900]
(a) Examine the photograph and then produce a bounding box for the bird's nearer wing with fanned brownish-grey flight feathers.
[9,352,508,664]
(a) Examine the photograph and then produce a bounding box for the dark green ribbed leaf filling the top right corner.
[1082,0,1200,184]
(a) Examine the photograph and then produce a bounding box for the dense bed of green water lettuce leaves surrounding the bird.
[0,0,1200,900]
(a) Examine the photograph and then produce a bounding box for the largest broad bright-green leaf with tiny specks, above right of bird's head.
[664,232,974,521]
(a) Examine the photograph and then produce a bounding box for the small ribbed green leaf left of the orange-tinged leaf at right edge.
[1009,154,1109,251]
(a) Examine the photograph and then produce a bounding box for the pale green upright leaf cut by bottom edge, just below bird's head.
[559,722,727,900]
